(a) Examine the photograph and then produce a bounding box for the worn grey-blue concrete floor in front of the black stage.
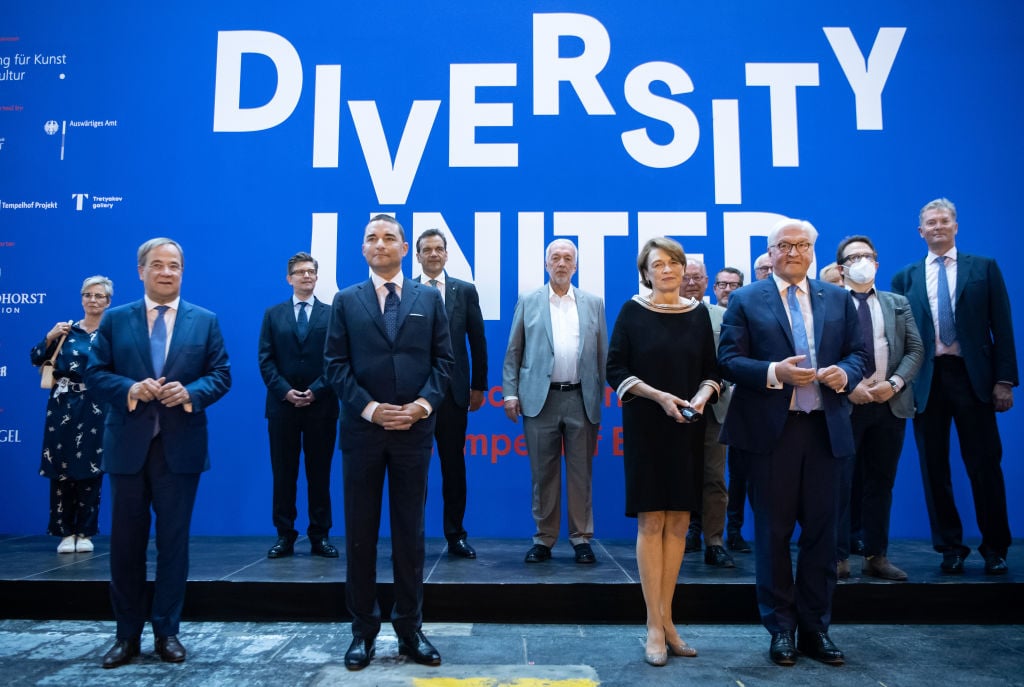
[0,622,1024,687]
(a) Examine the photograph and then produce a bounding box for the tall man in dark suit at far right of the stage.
[893,198,1018,574]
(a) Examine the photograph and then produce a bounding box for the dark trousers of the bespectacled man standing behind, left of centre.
[267,407,338,540]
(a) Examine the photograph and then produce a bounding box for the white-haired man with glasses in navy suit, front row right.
[719,219,865,665]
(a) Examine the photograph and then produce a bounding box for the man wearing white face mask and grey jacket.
[836,235,925,582]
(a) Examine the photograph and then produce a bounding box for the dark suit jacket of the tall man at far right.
[893,252,1018,413]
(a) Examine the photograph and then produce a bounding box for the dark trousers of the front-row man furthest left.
[110,435,199,640]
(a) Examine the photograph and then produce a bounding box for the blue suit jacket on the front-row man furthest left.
[86,300,231,474]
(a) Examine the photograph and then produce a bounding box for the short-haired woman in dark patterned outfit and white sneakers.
[32,275,114,554]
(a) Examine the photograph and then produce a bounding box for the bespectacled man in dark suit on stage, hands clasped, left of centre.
[259,253,338,558]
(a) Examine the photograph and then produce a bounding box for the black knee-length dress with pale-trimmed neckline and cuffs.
[607,296,719,517]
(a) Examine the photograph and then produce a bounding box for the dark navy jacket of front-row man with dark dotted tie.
[324,280,455,444]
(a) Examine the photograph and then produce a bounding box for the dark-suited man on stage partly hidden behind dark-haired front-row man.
[416,229,487,558]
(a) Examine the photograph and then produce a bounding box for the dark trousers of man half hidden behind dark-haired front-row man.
[434,389,469,542]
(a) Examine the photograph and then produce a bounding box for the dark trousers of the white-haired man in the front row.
[743,412,842,633]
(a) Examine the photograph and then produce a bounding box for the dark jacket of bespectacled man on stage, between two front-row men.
[259,298,338,420]
